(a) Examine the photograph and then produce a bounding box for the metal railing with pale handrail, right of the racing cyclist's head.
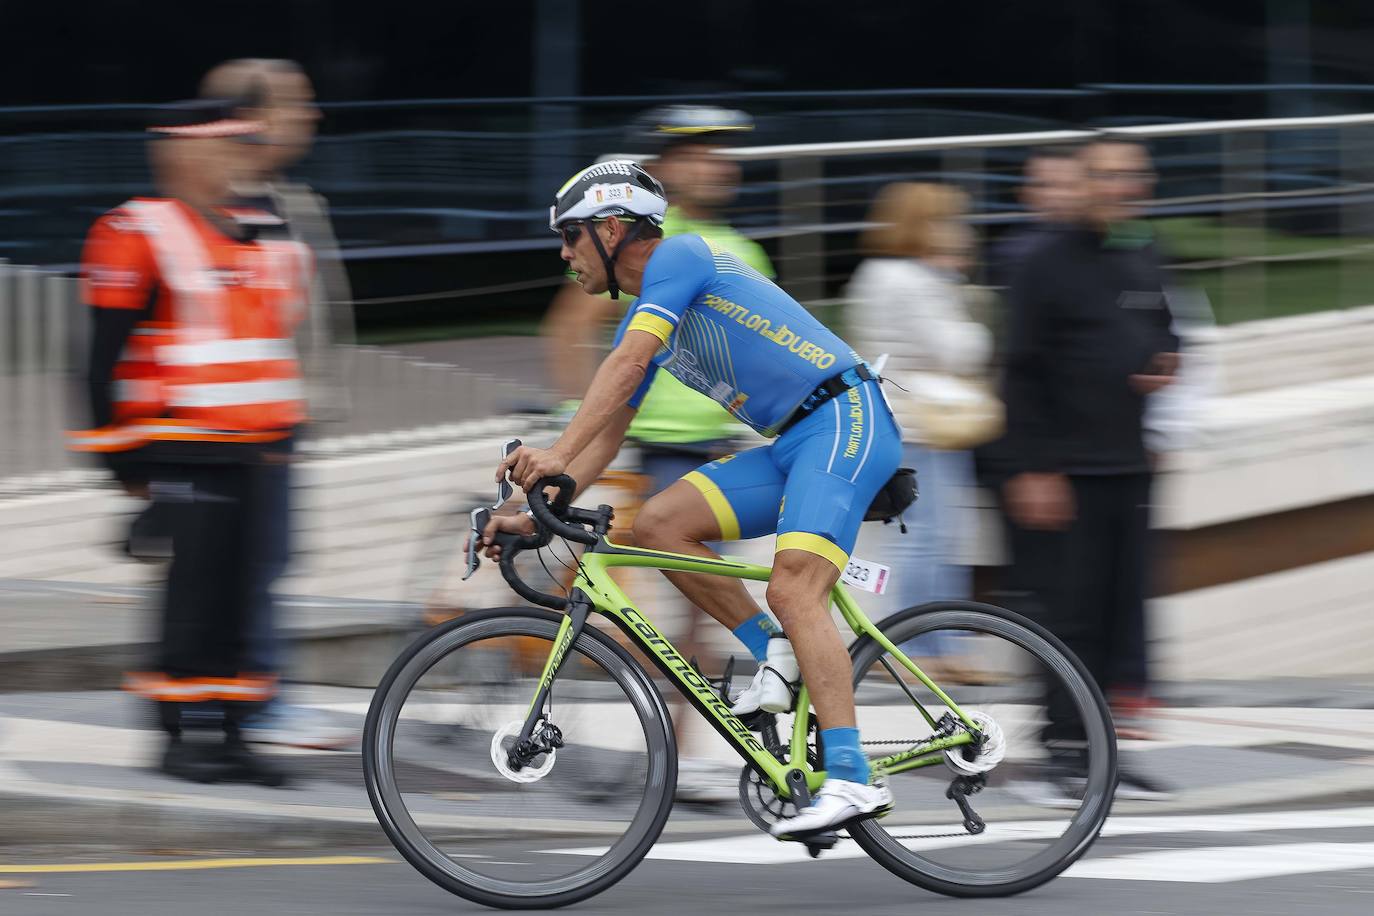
[727,114,1374,315]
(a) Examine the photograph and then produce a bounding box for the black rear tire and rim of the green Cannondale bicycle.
[849,602,1117,897]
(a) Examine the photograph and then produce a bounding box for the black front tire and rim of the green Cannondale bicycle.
[363,607,677,909]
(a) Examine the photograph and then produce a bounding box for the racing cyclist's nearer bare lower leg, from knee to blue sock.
[768,551,856,728]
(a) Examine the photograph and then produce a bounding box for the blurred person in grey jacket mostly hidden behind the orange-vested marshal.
[201,59,356,748]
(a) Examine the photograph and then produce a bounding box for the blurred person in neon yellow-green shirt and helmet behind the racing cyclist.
[544,104,775,802]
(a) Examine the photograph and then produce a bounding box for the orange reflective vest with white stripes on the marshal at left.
[70,199,313,452]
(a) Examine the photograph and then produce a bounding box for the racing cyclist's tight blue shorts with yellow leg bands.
[683,382,901,571]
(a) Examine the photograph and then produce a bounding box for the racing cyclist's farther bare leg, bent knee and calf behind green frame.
[635,481,763,629]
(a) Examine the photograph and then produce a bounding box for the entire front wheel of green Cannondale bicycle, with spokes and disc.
[363,607,677,909]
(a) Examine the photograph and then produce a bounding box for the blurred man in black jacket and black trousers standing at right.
[1003,139,1178,794]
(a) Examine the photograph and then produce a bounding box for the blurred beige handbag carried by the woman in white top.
[897,372,1006,452]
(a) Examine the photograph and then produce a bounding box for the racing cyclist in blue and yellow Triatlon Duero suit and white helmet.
[482,159,901,836]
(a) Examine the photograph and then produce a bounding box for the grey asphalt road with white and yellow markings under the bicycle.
[8,809,1374,916]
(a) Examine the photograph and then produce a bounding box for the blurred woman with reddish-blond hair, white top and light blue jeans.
[846,183,1002,681]
